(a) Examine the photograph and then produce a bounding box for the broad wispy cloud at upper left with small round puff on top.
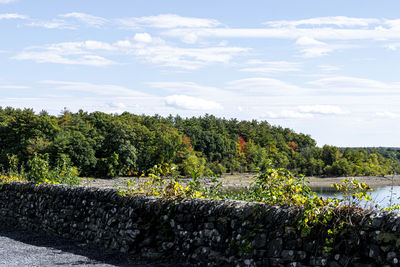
[14,35,248,69]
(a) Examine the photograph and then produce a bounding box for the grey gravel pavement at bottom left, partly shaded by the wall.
[0,226,186,267]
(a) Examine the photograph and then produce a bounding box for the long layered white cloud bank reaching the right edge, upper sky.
[162,16,400,57]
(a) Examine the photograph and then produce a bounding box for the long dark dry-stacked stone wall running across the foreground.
[0,183,400,266]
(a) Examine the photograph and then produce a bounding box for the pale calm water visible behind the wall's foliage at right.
[312,186,400,208]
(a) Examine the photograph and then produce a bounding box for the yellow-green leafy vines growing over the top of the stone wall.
[119,166,376,253]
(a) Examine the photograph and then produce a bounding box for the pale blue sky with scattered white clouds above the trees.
[0,0,400,147]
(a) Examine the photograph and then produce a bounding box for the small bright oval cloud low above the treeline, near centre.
[165,95,222,110]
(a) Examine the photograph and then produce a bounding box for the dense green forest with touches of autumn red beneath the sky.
[0,107,400,177]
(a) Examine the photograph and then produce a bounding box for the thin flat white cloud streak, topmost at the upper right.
[264,16,380,27]
